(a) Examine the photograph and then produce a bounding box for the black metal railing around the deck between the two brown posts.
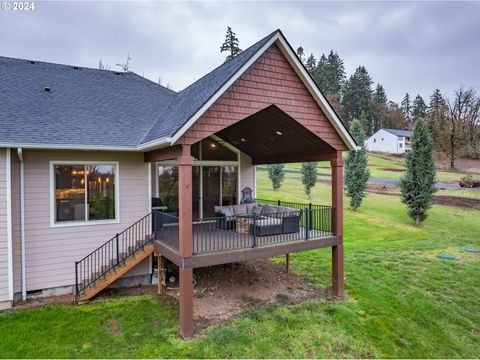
[192,200,333,254]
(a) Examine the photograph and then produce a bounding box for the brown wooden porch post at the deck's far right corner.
[330,152,344,299]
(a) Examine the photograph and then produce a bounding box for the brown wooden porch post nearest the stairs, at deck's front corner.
[177,145,193,338]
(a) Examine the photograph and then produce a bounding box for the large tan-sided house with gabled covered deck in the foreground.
[0,30,356,337]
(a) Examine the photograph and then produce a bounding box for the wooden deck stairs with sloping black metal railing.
[75,212,155,302]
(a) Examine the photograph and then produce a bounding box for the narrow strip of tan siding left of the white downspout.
[0,149,8,302]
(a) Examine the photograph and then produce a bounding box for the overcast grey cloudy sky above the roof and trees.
[0,0,480,101]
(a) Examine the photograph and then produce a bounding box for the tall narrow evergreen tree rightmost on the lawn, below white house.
[400,119,436,224]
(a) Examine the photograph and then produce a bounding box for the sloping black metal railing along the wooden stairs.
[75,212,155,297]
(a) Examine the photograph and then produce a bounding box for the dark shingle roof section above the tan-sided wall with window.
[0,57,176,147]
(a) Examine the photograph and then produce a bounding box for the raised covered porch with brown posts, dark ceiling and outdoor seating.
[145,105,343,337]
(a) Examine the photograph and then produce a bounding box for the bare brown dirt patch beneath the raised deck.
[166,260,327,327]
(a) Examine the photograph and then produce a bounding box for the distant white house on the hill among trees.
[365,129,413,154]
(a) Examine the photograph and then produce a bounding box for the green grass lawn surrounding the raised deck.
[0,172,480,358]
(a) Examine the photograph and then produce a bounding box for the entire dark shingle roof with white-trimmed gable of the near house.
[0,30,356,150]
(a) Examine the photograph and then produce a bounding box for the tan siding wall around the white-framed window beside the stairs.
[18,150,149,291]
